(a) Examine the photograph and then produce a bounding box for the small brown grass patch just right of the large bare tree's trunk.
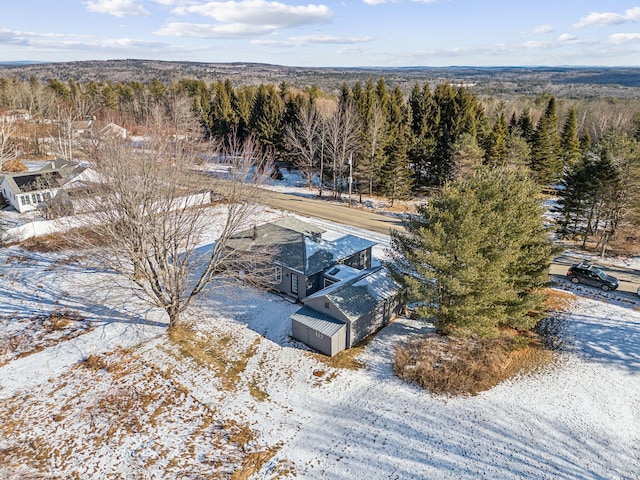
[169,324,260,391]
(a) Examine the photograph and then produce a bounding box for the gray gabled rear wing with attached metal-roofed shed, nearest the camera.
[291,267,402,356]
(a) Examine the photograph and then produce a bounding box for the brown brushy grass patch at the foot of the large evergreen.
[394,331,553,395]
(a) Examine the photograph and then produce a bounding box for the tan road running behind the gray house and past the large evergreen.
[262,192,640,293]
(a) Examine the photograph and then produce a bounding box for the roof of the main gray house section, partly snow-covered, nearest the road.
[229,217,376,277]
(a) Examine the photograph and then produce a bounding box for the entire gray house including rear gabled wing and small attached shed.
[229,217,401,356]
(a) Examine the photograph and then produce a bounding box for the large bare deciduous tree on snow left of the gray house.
[78,119,271,329]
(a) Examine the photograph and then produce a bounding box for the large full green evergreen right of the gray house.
[389,168,554,336]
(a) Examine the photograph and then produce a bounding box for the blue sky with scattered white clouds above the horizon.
[0,0,640,66]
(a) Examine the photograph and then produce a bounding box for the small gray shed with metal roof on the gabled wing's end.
[291,307,347,357]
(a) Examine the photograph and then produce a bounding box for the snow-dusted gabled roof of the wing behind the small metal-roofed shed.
[307,267,400,321]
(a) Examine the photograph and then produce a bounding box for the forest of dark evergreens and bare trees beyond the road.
[0,73,640,252]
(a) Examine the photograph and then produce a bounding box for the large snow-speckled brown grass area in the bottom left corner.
[0,350,270,479]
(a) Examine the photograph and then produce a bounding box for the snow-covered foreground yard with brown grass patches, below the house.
[0,207,640,480]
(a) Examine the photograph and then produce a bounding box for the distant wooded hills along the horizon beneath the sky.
[0,60,640,98]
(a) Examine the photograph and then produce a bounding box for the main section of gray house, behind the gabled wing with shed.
[229,217,376,301]
